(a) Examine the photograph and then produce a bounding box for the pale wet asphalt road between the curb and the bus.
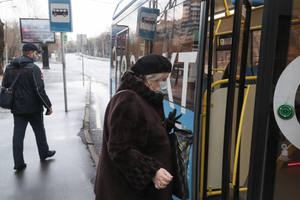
[66,54,110,154]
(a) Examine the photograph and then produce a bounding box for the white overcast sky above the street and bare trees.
[0,0,120,40]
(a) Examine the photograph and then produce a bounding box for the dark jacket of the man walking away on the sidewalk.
[2,56,52,114]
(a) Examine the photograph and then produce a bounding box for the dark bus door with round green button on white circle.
[247,0,300,200]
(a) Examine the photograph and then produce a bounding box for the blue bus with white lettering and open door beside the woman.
[110,0,300,200]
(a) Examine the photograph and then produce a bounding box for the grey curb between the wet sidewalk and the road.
[83,74,99,169]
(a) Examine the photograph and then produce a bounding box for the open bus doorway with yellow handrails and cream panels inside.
[192,0,256,200]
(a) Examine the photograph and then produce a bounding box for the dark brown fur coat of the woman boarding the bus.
[95,72,172,200]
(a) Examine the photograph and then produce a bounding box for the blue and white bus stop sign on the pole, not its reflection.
[49,0,72,32]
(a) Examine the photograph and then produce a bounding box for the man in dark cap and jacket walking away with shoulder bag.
[2,43,55,171]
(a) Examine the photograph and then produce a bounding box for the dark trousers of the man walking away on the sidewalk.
[13,112,49,166]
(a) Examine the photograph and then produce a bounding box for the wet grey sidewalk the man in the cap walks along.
[0,63,96,200]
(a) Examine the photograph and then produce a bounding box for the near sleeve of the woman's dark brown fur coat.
[108,95,162,191]
